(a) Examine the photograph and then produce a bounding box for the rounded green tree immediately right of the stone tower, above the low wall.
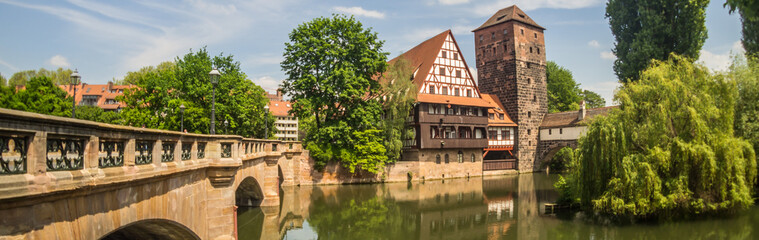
[546,61,582,113]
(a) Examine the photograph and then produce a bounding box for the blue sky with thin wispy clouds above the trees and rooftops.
[0,0,742,103]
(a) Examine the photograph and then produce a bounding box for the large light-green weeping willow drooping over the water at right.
[557,55,757,219]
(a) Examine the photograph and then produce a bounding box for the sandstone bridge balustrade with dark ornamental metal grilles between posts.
[0,108,302,201]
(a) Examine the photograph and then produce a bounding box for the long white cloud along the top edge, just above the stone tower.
[472,0,606,16]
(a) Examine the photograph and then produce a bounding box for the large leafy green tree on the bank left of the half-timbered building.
[281,15,387,173]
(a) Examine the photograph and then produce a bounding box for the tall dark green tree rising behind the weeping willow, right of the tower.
[606,0,709,83]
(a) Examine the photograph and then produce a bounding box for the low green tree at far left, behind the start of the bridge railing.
[0,77,72,117]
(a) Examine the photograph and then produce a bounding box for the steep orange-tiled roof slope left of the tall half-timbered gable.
[388,30,451,89]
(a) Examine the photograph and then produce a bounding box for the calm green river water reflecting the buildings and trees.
[238,174,759,239]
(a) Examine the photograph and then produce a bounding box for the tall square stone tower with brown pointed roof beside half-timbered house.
[472,5,548,172]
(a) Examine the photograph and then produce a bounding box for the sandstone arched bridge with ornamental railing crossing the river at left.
[0,109,308,239]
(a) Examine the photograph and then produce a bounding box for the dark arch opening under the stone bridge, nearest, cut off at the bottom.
[100,219,200,240]
